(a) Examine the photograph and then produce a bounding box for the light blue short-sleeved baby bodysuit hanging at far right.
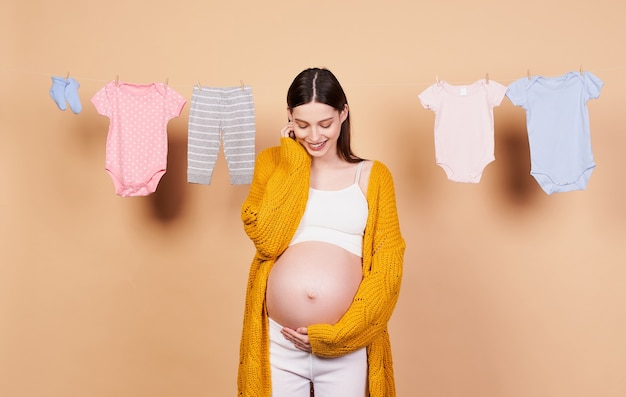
[506,72,603,194]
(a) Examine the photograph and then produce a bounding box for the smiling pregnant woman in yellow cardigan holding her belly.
[238,68,405,397]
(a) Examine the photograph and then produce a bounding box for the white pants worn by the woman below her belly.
[269,318,367,397]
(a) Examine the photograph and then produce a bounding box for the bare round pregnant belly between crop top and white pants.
[266,241,363,329]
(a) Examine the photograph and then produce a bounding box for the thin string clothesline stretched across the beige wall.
[0,66,626,90]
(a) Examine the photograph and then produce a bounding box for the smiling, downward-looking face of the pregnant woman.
[289,102,348,159]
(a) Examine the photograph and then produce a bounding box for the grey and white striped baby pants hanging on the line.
[187,86,256,185]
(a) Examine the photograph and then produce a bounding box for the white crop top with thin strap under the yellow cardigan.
[289,161,368,257]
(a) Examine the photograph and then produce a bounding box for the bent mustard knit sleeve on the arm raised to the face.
[241,138,311,259]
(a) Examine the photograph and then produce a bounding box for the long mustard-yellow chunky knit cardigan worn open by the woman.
[237,138,405,397]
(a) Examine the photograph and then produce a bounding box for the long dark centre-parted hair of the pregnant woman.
[287,68,363,163]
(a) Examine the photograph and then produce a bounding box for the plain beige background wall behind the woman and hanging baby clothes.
[0,0,626,397]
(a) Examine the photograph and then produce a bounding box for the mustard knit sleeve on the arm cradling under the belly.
[308,163,405,357]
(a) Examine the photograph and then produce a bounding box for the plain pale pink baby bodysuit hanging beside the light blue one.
[419,79,506,183]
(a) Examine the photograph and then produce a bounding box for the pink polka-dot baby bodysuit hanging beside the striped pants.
[91,81,186,197]
